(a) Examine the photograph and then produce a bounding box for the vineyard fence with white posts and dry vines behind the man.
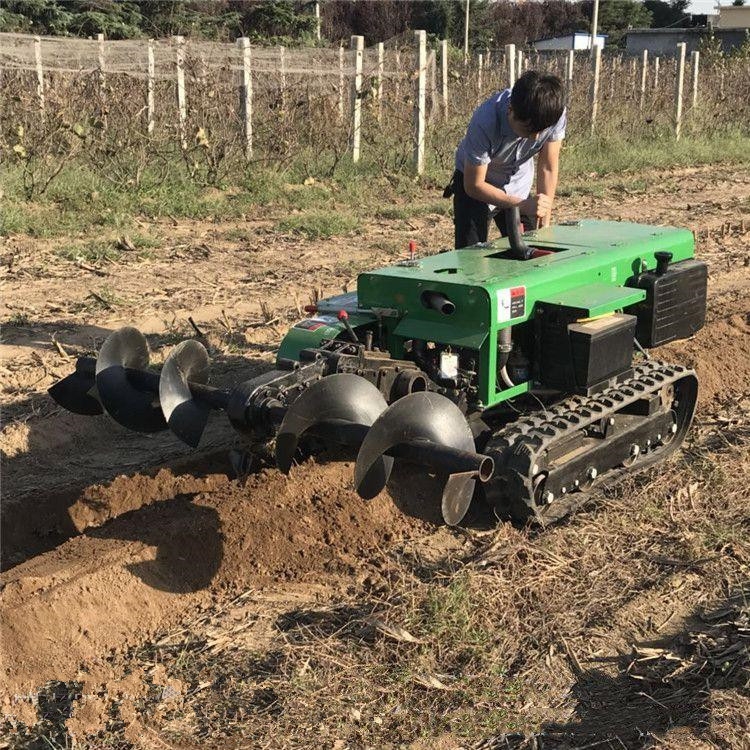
[0,31,750,198]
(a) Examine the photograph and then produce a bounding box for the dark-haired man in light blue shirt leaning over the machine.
[445,70,567,248]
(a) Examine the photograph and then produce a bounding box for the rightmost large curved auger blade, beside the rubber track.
[354,391,482,525]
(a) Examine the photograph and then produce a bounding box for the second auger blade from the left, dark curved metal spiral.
[96,326,167,432]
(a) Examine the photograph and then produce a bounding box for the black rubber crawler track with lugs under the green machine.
[484,359,697,523]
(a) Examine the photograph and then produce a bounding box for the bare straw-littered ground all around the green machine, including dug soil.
[0,166,750,750]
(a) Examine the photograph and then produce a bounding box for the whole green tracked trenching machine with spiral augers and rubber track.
[50,211,707,524]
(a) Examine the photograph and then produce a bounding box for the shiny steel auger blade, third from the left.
[159,339,211,448]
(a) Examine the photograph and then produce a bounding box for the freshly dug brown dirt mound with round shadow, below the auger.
[0,463,426,710]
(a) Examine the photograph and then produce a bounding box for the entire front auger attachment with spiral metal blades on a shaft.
[54,327,494,524]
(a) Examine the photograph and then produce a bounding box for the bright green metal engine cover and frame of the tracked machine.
[279,220,694,408]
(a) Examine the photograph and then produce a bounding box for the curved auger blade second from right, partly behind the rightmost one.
[276,373,393,484]
